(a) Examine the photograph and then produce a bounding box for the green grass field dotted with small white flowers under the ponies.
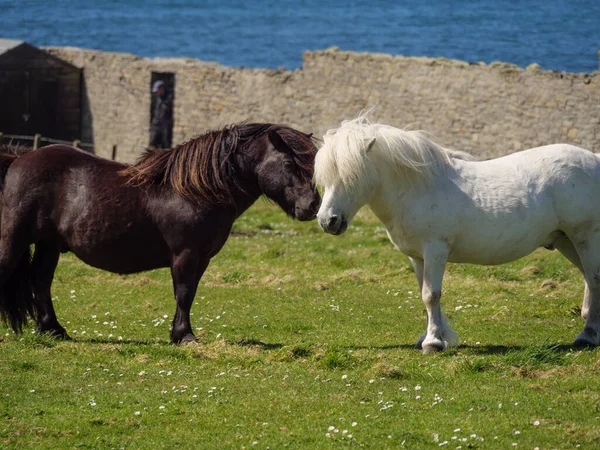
[0,201,600,449]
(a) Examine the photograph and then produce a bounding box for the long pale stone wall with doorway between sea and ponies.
[47,47,600,161]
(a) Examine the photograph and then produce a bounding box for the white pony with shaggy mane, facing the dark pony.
[315,115,600,353]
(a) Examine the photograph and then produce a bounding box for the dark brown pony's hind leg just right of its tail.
[31,243,71,339]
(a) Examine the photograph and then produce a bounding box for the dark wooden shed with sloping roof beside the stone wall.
[0,39,82,141]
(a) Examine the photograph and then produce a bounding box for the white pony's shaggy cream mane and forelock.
[315,113,474,190]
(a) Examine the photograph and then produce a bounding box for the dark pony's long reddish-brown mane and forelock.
[120,122,317,203]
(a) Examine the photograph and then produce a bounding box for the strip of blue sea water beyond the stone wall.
[0,0,600,72]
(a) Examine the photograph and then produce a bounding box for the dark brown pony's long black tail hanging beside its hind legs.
[0,247,36,334]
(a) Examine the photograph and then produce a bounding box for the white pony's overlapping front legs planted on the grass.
[411,242,458,353]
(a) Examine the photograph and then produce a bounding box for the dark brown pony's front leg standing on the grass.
[171,249,210,344]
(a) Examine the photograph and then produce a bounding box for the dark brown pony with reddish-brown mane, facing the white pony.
[0,123,320,343]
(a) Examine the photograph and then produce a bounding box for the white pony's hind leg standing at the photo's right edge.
[574,233,600,346]
